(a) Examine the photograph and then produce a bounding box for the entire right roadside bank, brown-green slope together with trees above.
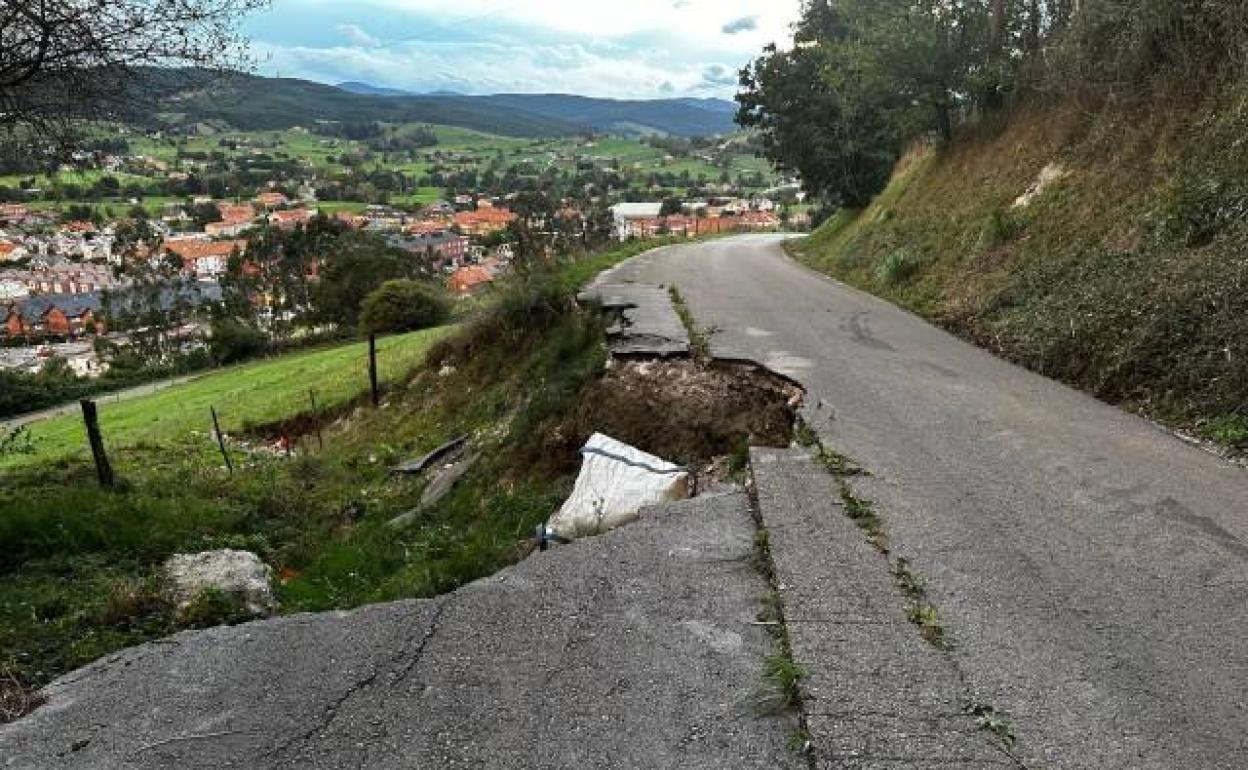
[739,0,1248,449]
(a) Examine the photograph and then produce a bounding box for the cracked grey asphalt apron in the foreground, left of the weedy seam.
[0,493,805,770]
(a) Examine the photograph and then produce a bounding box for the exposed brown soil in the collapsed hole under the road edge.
[548,359,804,470]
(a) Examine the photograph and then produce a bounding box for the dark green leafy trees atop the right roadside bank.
[738,0,1248,207]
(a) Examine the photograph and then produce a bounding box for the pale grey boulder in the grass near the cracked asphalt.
[165,550,277,618]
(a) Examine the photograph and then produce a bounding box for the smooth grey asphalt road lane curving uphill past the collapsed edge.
[610,236,1248,769]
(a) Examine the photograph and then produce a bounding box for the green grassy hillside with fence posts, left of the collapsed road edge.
[0,238,663,686]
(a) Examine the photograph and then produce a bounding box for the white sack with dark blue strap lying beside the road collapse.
[547,433,689,538]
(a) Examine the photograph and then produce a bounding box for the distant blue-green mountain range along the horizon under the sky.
[158,71,736,137]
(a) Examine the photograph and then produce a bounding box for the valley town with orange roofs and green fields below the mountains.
[0,124,809,378]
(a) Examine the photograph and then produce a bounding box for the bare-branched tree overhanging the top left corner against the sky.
[0,0,268,137]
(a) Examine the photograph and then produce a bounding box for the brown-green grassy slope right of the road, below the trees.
[795,90,1248,444]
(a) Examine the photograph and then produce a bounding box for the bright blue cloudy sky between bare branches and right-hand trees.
[247,0,800,99]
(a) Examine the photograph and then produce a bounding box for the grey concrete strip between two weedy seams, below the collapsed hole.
[750,449,1010,768]
